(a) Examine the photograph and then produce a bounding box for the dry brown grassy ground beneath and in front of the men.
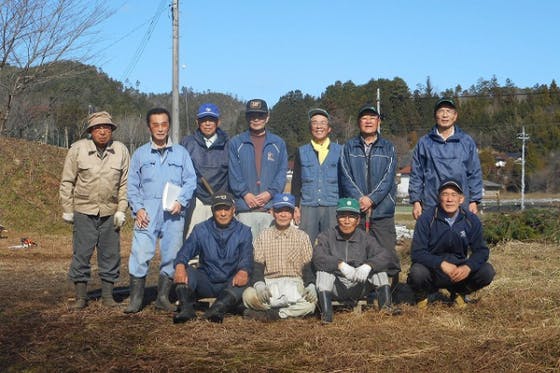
[0,232,560,372]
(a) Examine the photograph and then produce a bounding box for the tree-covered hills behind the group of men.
[0,62,560,192]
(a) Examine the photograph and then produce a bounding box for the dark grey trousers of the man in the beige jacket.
[68,212,121,283]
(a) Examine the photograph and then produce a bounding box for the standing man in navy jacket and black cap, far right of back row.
[408,98,482,219]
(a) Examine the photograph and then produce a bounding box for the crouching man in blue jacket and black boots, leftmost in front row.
[173,193,253,323]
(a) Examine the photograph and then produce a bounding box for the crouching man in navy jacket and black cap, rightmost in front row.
[407,179,495,308]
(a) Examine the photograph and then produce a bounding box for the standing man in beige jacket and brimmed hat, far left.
[59,111,130,309]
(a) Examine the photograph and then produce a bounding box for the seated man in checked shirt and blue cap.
[243,193,317,321]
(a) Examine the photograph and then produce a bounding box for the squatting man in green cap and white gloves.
[313,198,400,323]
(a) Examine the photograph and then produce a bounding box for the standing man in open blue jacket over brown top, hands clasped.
[228,98,288,238]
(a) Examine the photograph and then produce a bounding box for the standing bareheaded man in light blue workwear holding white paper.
[125,108,196,313]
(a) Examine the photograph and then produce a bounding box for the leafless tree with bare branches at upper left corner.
[0,0,110,135]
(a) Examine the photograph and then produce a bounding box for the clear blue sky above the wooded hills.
[92,0,560,106]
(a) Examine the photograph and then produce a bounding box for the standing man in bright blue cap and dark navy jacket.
[181,103,229,236]
